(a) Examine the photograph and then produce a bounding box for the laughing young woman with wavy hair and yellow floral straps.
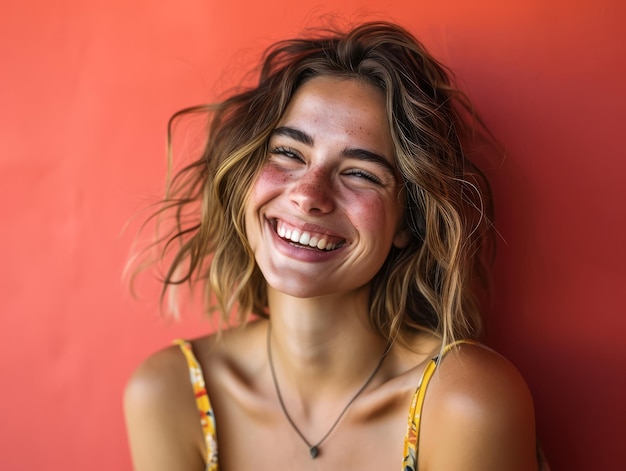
[125,23,538,471]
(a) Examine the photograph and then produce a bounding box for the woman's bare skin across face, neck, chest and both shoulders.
[125,77,536,471]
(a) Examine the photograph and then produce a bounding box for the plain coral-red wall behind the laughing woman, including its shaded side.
[0,0,626,471]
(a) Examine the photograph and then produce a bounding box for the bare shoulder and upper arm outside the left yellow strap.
[124,347,205,471]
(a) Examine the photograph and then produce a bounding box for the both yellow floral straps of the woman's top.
[175,340,474,471]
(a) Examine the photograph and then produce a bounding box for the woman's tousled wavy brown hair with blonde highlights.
[132,22,494,343]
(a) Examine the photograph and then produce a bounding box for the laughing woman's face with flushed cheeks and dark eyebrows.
[246,76,409,298]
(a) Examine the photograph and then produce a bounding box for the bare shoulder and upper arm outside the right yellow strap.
[419,344,537,471]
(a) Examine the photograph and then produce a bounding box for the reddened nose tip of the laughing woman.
[289,168,335,213]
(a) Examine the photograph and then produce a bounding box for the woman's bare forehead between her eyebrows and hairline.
[279,76,393,157]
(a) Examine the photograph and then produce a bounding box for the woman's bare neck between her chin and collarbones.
[269,289,386,414]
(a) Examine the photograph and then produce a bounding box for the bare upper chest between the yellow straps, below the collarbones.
[216,391,411,471]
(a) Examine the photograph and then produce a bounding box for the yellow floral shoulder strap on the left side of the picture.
[174,339,219,471]
